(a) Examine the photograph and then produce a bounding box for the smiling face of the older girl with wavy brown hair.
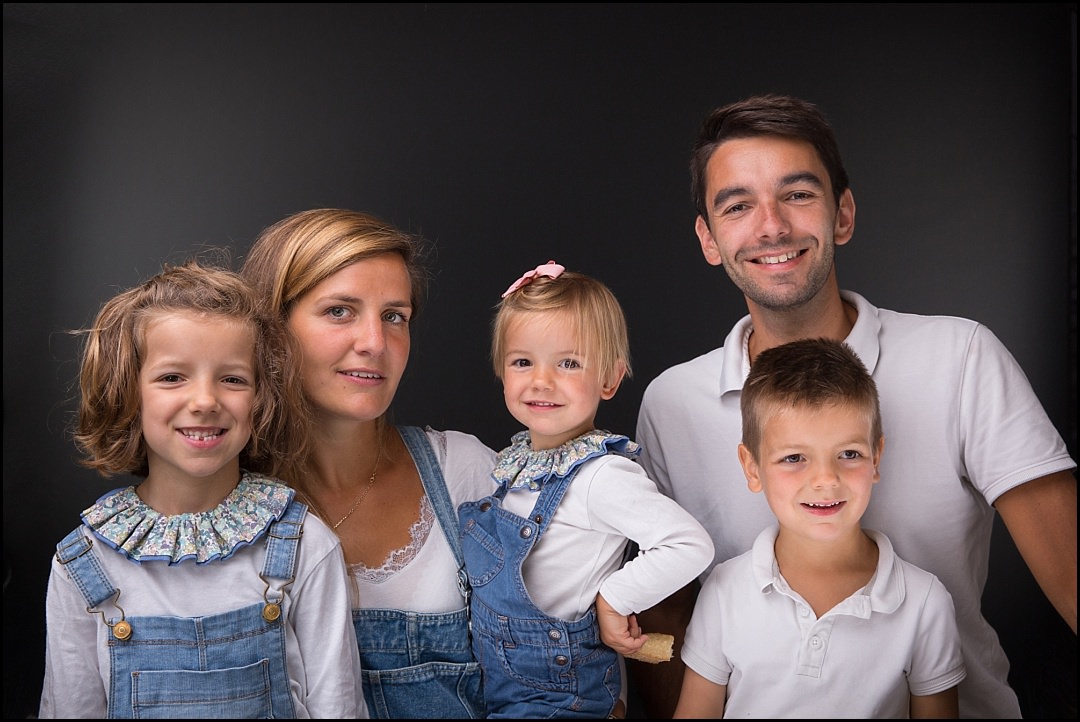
[139,312,256,485]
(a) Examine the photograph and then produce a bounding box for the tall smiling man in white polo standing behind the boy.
[627,95,1077,718]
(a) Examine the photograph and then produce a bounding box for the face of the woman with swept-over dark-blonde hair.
[288,254,413,421]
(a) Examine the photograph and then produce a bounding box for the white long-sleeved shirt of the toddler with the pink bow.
[494,454,713,621]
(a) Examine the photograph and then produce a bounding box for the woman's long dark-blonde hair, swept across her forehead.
[240,208,429,486]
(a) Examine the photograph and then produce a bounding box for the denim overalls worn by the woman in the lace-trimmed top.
[352,426,484,719]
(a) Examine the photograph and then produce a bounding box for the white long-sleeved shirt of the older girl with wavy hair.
[39,500,368,719]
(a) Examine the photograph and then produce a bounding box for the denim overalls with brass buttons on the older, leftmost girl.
[56,501,308,719]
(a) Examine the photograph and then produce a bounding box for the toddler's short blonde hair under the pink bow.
[491,271,632,382]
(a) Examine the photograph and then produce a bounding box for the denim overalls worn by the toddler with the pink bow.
[458,467,622,719]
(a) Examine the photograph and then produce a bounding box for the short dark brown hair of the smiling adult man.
[690,95,849,220]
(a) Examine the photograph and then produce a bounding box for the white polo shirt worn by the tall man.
[636,291,1076,718]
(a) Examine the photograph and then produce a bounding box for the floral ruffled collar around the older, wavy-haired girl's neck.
[82,472,295,564]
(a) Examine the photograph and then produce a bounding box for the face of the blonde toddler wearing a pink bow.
[502,313,618,449]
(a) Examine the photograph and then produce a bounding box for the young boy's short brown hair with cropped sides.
[740,339,883,460]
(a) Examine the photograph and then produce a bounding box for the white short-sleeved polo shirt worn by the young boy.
[683,526,964,719]
